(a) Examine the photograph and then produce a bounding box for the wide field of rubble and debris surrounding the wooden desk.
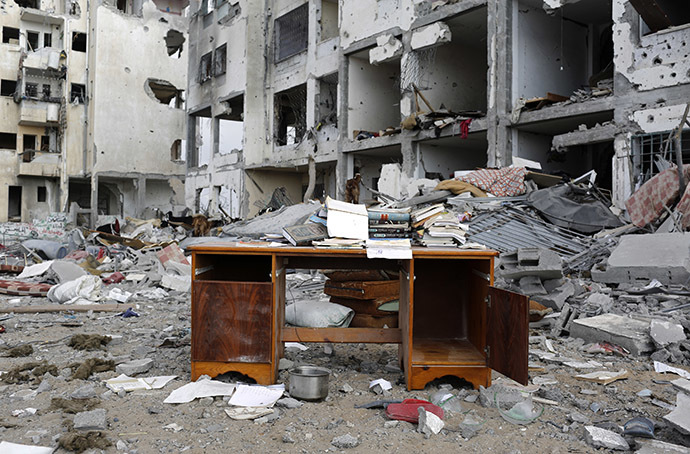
[0,159,690,453]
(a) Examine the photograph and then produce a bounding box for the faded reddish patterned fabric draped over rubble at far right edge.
[625,164,690,228]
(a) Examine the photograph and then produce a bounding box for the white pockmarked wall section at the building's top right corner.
[613,0,690,91]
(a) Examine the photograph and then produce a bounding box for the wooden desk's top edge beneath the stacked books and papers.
[189,241,499,258]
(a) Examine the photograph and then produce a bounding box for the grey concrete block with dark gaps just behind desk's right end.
[496,248,563,279]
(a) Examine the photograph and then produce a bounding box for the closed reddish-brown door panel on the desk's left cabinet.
[192,281,273,363]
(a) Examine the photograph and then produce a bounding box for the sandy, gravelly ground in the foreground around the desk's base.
[0,295,690,453]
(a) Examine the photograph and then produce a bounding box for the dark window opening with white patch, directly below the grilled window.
[275,84,307,145]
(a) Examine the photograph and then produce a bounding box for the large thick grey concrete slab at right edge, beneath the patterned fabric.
[591,232,690,285]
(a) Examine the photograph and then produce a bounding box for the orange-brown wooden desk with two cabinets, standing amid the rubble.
[190,243,529,389]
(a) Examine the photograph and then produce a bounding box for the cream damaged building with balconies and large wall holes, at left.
[0,0,188,225]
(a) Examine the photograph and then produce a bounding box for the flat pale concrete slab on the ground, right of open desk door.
[570,314,654,355]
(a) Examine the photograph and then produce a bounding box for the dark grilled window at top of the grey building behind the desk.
[273,3,309,63]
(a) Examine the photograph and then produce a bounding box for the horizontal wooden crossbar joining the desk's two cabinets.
[281,327,402,344]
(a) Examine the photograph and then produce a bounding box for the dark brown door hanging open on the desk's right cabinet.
[486,287,529,385]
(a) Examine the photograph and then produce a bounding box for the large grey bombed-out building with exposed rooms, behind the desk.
[186,0,690,218]
